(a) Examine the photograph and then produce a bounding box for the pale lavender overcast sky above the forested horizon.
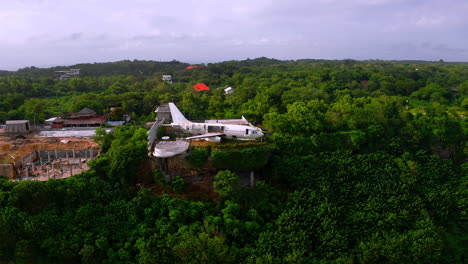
[0,0,468,70]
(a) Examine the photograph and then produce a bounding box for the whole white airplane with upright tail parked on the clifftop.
[169,103,263,142]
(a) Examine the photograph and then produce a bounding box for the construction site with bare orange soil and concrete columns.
[0,133,100,181]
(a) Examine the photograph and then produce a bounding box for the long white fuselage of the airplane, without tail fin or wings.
[171,122,263,140]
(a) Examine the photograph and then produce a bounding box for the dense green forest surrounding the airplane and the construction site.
[0,58,468,263]
